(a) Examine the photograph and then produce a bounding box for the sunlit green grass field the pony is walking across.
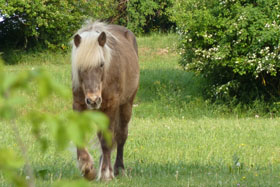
[0,34,280,186]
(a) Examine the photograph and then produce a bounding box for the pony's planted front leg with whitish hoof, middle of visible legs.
[98,104,118,181]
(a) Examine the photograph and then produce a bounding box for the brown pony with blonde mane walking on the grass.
[72,22,139,180]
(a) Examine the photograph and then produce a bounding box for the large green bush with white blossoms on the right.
[170,0,280,102]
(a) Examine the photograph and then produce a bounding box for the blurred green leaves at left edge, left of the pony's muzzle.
[0,67,70,120]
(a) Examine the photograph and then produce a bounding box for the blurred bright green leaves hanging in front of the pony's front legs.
[28,111,111,151]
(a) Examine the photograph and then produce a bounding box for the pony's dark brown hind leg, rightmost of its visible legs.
[114,102,132,175]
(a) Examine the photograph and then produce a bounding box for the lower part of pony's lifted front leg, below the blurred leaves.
[77,148,96,180]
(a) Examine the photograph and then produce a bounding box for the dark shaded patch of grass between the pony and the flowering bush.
[137,69,203,102]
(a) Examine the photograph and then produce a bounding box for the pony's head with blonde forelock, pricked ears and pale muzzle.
[72,22,113,109]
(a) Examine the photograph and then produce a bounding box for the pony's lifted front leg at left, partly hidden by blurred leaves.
[73,91,96,180]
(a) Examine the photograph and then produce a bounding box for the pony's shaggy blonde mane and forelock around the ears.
[71,21,117,89]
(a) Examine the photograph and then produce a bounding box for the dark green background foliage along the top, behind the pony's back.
[0,0,174,50]
